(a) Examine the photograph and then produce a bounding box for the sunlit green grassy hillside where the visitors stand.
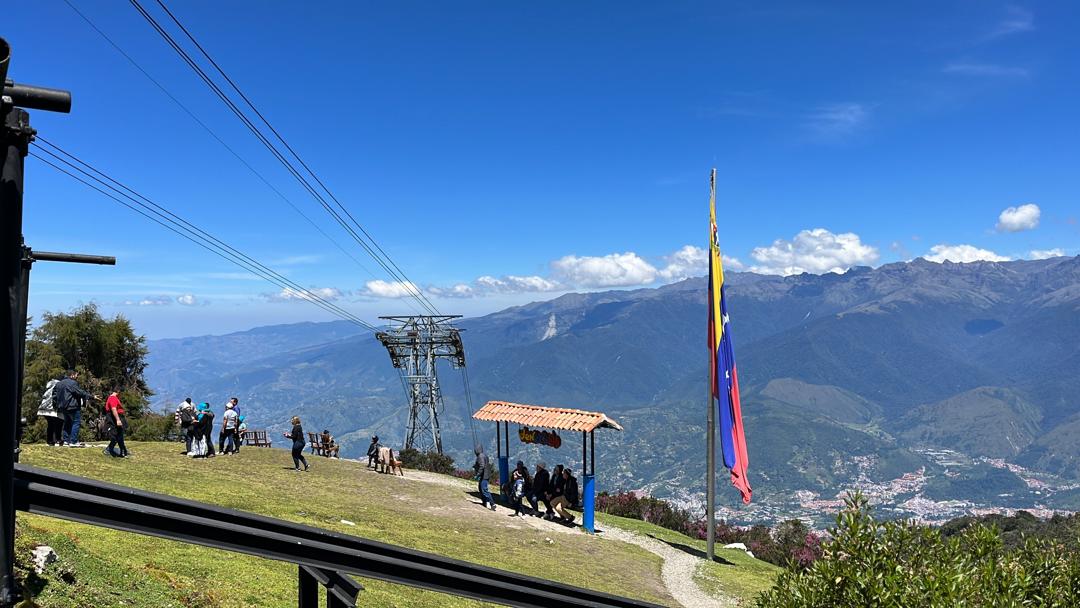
[17,443,778,608]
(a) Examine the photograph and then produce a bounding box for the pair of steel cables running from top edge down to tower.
[130,0,438,314]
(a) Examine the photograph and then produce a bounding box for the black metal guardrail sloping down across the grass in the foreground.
[15,464,657,608]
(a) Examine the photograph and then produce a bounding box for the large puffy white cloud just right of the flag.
[750,228,879,275]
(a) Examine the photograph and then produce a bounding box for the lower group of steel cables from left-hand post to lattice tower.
[30,141,376,332]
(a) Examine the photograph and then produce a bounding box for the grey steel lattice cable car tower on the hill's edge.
[375,314,465,454]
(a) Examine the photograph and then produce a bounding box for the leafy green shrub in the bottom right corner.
[757,494,1080,608]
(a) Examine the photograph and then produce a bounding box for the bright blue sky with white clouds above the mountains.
[6,0,1080,337]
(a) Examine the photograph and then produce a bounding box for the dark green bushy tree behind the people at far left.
[22,303,153,431]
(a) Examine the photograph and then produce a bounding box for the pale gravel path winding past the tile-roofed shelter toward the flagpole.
[388,471,735,608]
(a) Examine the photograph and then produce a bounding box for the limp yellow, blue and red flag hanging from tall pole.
[708,168,751,503]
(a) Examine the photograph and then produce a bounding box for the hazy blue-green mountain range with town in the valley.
[148,256,1080,519]
